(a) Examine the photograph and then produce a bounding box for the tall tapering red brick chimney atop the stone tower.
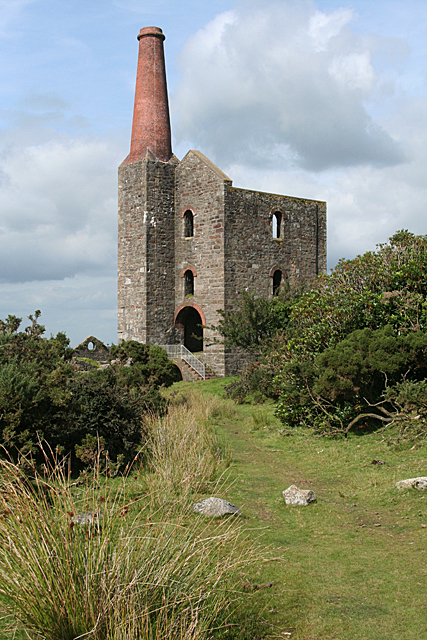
[122,27,172,165]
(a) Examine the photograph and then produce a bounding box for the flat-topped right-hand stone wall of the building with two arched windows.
[224,184,326,373]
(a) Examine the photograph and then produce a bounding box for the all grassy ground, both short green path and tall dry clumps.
[0,379,427,640]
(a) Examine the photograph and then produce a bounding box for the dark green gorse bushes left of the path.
[0,312,174,469]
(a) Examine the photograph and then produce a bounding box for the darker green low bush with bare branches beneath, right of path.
[276,325,427,431]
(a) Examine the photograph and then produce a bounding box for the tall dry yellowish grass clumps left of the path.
[0,392,254,640]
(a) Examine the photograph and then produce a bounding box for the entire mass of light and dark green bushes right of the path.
[274,231,427,433]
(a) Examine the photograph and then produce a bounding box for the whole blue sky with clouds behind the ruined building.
[0,0,427,345]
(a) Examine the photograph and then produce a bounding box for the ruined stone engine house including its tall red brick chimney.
[118,27,326,375]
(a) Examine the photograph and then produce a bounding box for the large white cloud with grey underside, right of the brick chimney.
[172,1,404,171]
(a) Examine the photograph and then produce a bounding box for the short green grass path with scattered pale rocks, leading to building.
[176,380,427,640]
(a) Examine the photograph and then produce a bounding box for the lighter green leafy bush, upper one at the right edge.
[285,231,427,358]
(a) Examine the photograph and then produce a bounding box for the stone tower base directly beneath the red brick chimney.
[118,158,176,344]
